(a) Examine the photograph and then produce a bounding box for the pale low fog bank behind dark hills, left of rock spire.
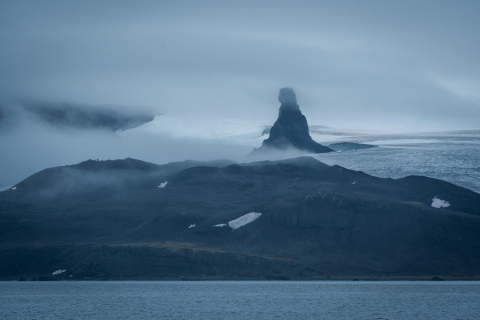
[0,112,255,186]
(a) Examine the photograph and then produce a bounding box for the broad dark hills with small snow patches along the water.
[0,157,480,279]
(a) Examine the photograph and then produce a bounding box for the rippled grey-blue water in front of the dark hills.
[0,281,480,319]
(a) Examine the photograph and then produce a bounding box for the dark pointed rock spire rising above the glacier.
[251,88,332,155]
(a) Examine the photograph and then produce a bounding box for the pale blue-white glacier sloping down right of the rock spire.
[312,130,480,193]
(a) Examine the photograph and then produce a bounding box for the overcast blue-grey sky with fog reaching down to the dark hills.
[0,0,480,186]
